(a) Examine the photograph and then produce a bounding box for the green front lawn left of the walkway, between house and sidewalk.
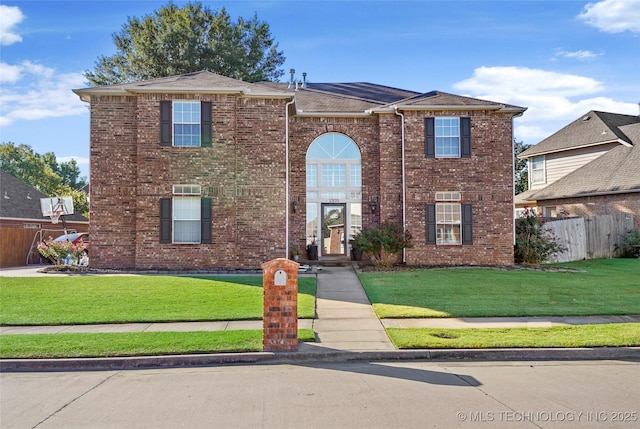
[0,276,316,325]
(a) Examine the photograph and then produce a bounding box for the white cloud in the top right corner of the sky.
[578,0,640,33]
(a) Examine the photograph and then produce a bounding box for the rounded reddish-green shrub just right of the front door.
[350,223,413,269]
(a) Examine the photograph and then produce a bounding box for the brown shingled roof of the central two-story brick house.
[74,70,526,116]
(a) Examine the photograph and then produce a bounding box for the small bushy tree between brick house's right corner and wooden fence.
[514,208,567,265]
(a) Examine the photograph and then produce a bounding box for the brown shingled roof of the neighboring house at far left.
[0,170,89,222]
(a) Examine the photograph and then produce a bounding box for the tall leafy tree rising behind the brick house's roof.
[84,3,285,85]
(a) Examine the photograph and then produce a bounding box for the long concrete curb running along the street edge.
[0,347,640,372]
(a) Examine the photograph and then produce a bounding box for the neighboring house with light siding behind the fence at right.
[516,111,640,217]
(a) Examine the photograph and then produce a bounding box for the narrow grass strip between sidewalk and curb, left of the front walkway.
[0,329,315,359]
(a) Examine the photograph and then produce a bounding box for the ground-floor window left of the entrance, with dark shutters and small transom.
[160,185,212,244]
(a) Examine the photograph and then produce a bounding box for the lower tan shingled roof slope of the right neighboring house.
[529,120,640,201]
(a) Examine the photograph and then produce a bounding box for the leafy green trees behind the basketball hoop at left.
[0,142,89,216]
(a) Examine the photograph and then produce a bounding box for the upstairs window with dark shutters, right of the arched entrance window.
[424,117,471,158]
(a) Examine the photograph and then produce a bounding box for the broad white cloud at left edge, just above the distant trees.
[0,61,87,126]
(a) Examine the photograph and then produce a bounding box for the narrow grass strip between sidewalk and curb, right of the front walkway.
[387,323,640,349]
